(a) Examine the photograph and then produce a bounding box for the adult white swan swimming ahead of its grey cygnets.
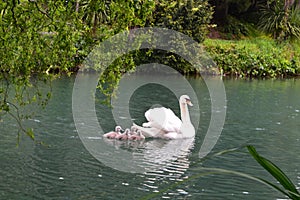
[133,95,195,139]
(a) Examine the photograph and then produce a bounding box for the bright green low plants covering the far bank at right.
[203,37,300,78]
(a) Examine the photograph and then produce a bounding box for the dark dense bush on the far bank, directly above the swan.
[134,0,213,74]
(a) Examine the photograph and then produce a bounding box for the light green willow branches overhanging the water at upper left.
[0,0,153,139]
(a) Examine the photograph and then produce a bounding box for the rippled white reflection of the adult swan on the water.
[105,134,194,195]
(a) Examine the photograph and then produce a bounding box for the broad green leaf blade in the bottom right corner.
[247,145,300,199]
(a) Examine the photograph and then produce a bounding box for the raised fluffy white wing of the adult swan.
[145,107,182,132]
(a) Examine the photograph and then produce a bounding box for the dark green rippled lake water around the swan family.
[0,74,300,199]
